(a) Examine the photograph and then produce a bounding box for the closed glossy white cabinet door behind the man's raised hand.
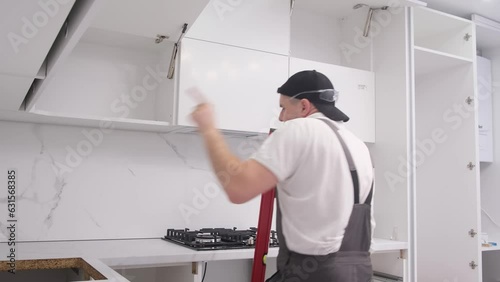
[178,38,288,133]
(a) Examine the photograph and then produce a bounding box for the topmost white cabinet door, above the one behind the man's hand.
[186,0,290,55]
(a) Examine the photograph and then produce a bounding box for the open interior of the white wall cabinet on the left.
[31,29,175,126]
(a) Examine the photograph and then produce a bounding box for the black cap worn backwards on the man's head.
[278,70,349,122]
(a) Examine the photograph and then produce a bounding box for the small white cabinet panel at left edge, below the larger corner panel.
[0,74,33,111]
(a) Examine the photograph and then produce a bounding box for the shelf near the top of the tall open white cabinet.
[414,46,473,77]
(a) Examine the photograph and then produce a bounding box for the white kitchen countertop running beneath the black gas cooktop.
[0,239,408,281]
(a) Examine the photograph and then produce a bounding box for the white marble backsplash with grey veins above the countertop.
[0,122,270,242]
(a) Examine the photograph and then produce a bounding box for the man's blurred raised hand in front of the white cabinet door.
[186,88,215,133]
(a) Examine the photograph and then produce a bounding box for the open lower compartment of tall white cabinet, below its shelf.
[414,61,481,282]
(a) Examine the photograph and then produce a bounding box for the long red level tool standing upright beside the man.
[252,129,275,282]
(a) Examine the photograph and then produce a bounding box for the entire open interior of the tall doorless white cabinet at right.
[411,8,481,282]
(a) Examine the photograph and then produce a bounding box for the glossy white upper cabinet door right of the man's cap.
[290,58,375,142]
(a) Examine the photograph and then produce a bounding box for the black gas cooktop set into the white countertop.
[162,227,279,251]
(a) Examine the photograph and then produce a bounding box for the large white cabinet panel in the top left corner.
[0,0,75,77]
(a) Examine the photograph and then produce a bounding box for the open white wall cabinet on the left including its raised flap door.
[18,0,208,131]
